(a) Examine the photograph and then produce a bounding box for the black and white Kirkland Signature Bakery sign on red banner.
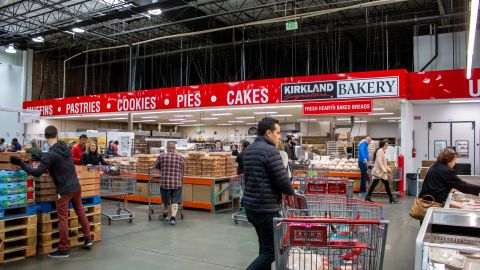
[282,76,399,102]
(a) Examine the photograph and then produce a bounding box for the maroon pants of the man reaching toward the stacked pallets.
[56,191,90,251]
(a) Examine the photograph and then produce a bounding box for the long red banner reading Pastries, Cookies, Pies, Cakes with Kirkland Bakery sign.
[23,70,407,116]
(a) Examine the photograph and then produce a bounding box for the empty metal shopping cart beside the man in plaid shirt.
[96,165,137,225]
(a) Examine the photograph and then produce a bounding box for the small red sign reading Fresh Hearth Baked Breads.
[303,100,373,115]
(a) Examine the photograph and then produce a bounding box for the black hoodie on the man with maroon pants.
[20,141,80,195]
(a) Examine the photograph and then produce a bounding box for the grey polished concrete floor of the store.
[6,197,419,270]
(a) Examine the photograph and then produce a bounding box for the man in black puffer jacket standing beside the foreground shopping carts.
[242,118,295,270]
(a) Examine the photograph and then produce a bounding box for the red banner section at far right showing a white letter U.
[407,68,480,100]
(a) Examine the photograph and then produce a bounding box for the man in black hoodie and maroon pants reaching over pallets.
[10,126,93,258]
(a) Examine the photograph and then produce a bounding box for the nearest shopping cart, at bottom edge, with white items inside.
[274,217,388,270]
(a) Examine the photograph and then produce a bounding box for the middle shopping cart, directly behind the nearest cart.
[284,194,384,220]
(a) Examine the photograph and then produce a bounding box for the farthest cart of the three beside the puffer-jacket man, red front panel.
[297,176,353,198]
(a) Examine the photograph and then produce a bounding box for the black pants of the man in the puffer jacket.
[247,210,280,270]
